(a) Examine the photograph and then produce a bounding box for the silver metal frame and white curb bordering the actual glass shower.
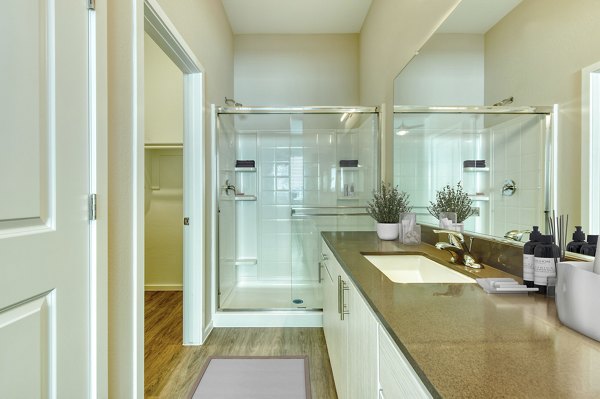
[211,104,385,327]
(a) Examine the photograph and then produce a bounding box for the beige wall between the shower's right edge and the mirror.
[359,0,460,182]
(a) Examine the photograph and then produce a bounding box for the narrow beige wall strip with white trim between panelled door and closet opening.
[107,0,144,398]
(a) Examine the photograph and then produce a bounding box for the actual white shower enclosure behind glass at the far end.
[215,107,380,311]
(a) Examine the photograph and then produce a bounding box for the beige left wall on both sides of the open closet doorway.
[107,0,233,398]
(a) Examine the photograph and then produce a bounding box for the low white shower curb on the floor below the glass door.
[213,311,323,327]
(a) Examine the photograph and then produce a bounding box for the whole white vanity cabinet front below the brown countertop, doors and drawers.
[321,241,431,399]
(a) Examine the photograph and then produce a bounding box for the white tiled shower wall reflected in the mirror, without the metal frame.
[394,115,545,236]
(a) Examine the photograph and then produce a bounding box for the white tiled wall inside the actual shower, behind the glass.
[236,124,377,284]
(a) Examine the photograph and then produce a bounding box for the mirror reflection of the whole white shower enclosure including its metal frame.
[393,106,555,237]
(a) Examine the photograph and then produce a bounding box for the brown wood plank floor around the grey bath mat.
[144,291,337,399]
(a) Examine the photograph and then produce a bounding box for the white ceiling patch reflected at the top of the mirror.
[436,0,522,34]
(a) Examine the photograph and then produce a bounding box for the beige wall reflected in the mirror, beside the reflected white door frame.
[485,0,600,225]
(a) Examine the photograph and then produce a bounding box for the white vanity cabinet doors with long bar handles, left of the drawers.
[321,243,377,399]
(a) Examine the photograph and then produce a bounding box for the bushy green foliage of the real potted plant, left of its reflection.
[367,182,412,223]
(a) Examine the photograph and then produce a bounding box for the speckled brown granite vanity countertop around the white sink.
[322,232,600,398]
